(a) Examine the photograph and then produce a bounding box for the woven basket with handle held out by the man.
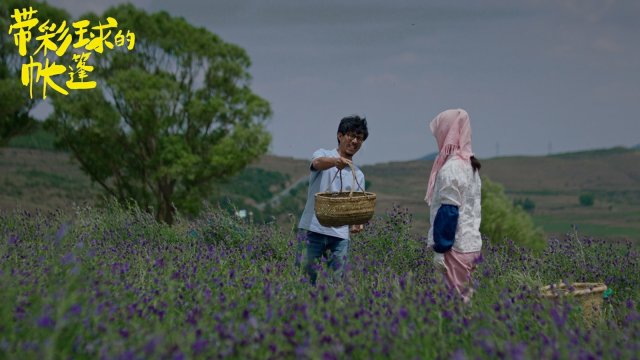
[315,164,376,227]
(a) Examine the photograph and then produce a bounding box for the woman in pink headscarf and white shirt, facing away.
[425,109,482,303]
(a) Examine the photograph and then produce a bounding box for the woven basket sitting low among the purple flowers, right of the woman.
[540,283,607,325]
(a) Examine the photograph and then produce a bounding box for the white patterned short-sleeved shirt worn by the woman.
[427,155,482,253]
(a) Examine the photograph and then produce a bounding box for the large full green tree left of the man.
[47,5,271,223]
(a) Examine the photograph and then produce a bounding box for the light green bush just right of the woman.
[480,177,545,250]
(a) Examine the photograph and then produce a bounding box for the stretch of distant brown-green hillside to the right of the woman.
[485,148,640,240]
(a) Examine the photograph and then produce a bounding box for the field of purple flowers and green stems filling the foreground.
[0,206,640,359]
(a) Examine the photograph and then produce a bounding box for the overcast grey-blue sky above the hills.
[40,0,640,164]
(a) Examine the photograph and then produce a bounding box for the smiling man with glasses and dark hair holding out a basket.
[298,115,369,285]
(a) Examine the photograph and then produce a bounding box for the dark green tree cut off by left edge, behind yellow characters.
[0,0,70,147]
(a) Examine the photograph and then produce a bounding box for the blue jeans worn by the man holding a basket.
[300,230,349,285]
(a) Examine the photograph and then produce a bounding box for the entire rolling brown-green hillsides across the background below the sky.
[0,141,640,240]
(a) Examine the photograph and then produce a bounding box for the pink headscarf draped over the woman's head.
[424,109,473,205]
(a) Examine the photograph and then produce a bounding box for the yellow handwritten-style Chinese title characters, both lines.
[9,6,136,99]
